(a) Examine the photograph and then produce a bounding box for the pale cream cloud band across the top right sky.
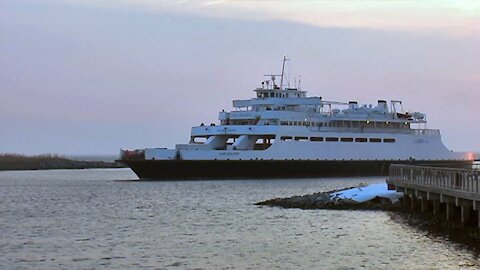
[51,0,480,35]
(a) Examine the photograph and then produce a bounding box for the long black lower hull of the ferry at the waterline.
[118,159,473,180]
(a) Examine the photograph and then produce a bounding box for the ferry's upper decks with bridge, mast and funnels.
[227,58,427,128]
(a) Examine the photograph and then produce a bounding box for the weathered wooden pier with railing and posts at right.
[387,164,480,228]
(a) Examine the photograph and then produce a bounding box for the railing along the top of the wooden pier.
[389,164,480,198]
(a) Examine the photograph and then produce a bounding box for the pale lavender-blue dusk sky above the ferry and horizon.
[0,0,480,155]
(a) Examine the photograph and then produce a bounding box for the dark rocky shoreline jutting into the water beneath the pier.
[255,184,480,253]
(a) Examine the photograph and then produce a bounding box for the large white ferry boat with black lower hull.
[118,57,474,180]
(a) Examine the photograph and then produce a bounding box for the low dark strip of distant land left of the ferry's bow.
[0,154,126,171]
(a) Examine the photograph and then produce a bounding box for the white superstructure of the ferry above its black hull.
[124,58,472,161]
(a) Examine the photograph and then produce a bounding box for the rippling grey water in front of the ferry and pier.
[0,169,480,269]
